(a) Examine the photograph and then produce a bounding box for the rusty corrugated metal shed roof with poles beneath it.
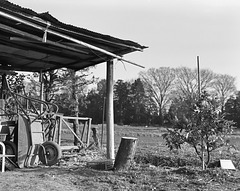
[0,0,147,71]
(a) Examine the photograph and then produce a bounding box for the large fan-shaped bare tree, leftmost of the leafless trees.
[139,67,175,125]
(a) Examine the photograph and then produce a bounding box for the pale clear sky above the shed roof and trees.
[10,0,240,90]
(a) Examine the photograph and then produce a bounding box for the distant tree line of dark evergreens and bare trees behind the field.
[5,67,240,125]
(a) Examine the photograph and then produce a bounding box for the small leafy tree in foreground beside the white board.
[163,92,234,167]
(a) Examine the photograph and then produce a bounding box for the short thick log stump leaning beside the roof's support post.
[113,137,137,170]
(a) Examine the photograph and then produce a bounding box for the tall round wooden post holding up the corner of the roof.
[106,60,114,159]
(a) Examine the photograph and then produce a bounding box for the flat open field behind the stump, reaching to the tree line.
[62,125,240,152]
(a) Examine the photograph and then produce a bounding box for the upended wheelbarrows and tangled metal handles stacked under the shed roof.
[0,74,62,168]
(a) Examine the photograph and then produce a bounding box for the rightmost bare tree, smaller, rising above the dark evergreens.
[212,74,236,112]
